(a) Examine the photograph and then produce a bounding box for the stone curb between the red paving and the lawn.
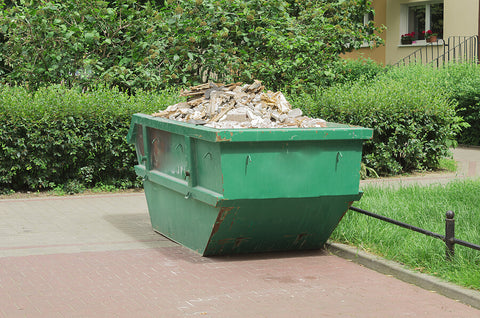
[325,242,480,309]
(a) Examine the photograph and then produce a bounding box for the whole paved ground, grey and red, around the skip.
[0,149,480,318]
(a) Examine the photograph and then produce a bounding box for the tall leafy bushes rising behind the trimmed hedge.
[0,0,381,91]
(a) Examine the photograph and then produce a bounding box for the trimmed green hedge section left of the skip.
[0,86,178,193]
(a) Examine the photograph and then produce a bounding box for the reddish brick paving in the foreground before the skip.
[0,246,480,318]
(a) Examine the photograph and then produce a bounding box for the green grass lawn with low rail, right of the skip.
[331,180,480,290]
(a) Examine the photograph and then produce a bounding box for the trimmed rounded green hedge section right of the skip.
[291,66,463,175]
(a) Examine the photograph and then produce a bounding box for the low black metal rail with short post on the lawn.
[350,206,480,260]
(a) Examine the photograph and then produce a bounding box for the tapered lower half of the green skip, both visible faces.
[145,180,361,256]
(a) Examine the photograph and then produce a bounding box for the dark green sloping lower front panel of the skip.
[204,194,361,256]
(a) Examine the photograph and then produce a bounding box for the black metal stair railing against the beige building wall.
[394,35,478,67]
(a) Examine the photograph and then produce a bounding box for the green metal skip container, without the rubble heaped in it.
[127,114,372,255]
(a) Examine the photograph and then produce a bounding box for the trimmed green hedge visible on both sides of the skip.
[0,62,470,193]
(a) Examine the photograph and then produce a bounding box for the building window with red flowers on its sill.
[402,1,443,41]
